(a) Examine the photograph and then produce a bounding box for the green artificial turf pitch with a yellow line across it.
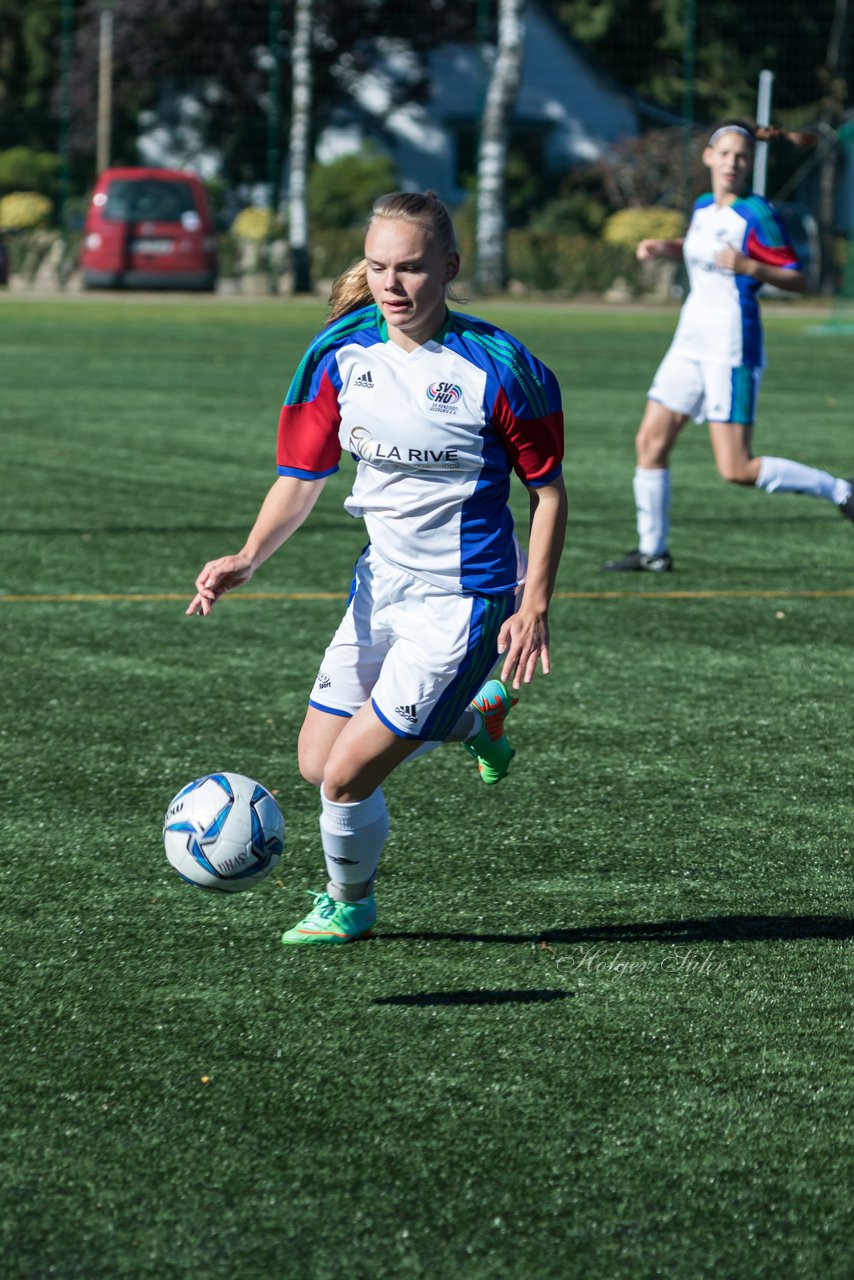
[0,297,854,1280]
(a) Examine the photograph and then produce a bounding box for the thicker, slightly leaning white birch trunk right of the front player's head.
[475,0,525,293]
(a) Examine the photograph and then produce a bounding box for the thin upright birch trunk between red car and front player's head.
[288,0,314,293]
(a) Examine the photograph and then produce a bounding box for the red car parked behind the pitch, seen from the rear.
[81,169,216,291]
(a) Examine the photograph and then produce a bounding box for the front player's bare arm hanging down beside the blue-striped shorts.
[498,476,567,689]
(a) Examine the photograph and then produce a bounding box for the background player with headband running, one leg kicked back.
[602,122,854,573]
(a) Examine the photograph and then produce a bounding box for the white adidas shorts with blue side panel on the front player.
[309,547,515,742]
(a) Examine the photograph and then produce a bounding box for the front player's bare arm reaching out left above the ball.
[187,476,325,617]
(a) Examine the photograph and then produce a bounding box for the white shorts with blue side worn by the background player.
[648,351,762,426]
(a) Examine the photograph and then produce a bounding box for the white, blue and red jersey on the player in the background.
[671,193,800,369]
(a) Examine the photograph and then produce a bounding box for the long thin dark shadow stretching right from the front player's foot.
[376,915,854,946]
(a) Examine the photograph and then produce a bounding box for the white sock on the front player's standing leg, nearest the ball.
[320,787,388,902]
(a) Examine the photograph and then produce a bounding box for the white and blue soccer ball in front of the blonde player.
[163,773,284,893]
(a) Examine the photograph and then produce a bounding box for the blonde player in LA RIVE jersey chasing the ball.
[187,192,566,945]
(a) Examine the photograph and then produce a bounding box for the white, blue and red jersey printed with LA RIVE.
[278,305,563,594]
